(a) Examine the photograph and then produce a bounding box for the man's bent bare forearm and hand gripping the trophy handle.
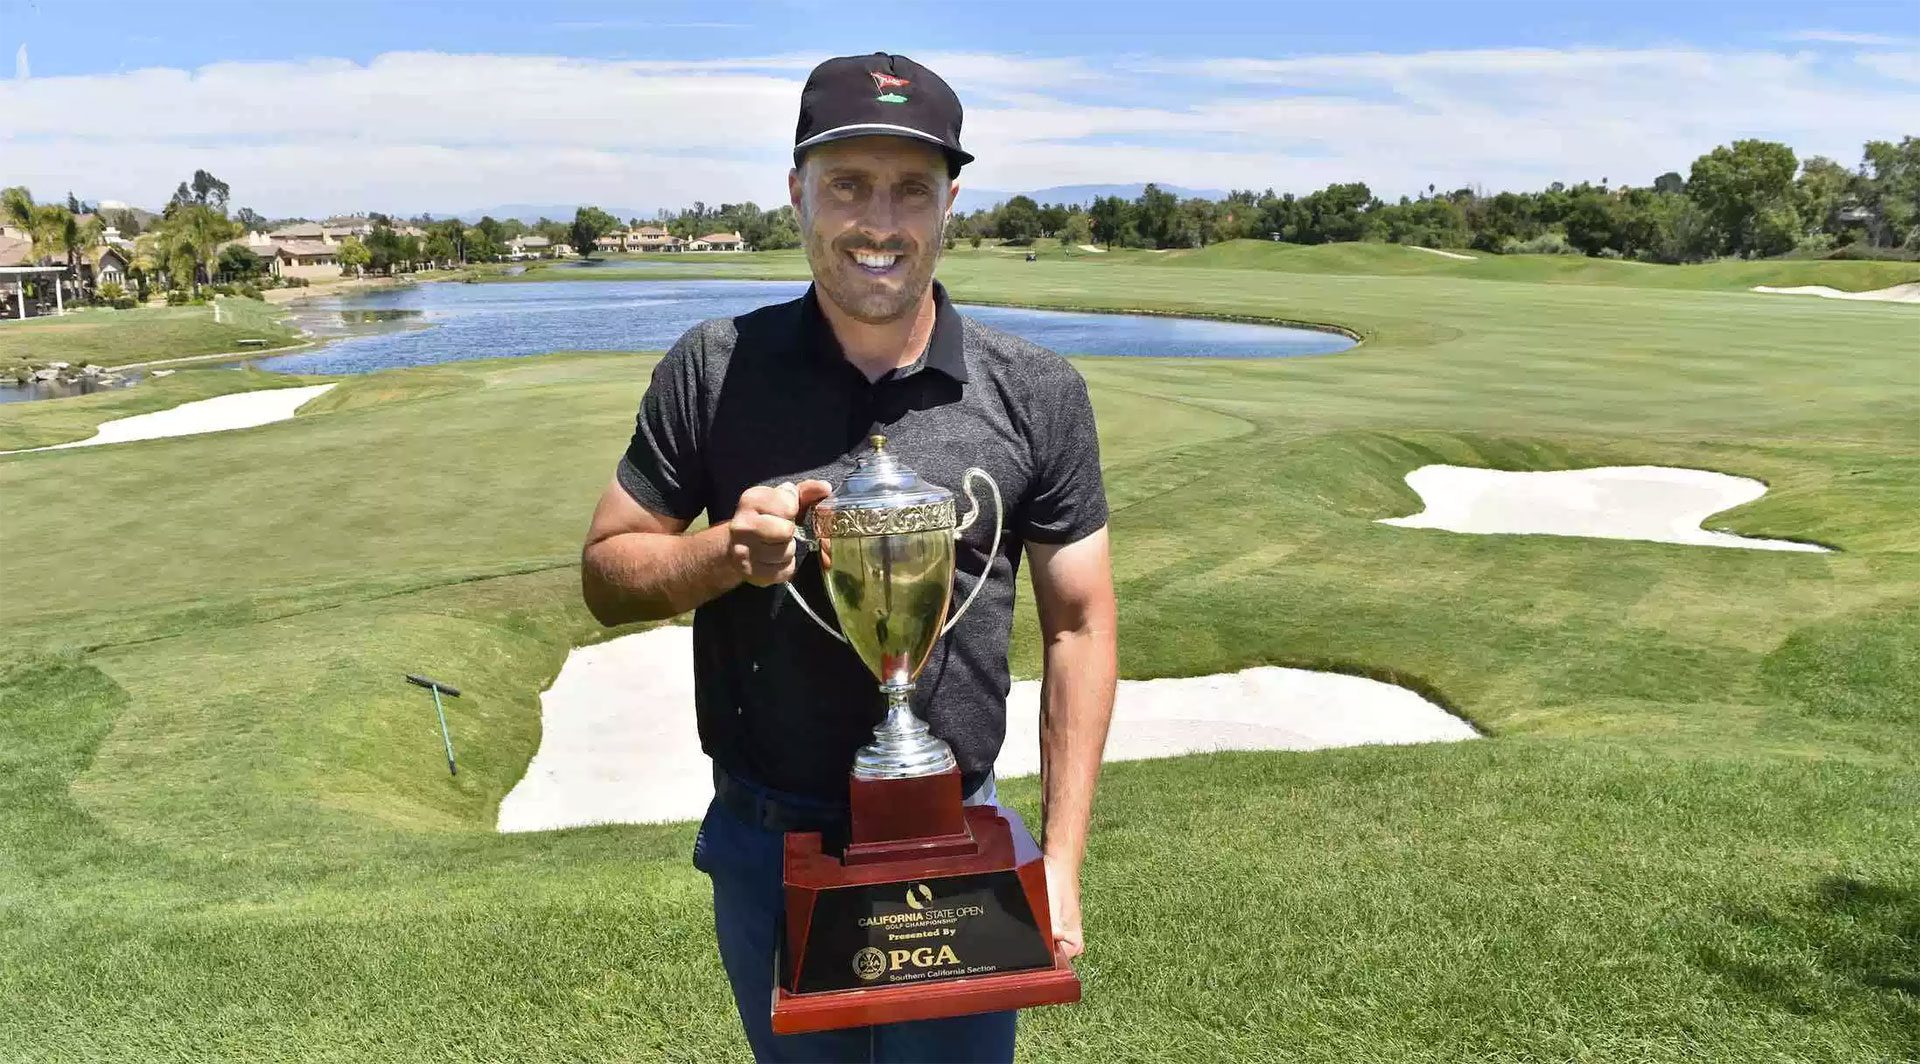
[580,478,829,628]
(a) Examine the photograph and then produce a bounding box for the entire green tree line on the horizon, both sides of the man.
[0,136,1920,296]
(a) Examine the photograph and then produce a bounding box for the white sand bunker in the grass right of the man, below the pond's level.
[1380,465,1826,551]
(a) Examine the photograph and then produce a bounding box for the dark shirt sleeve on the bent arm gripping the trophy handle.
[614,326,707,520]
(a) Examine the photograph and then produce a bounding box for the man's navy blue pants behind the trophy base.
[693,764,1018,1064]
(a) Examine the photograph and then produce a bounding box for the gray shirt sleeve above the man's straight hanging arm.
[1020,365,1108,544]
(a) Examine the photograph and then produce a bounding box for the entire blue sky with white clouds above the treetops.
[0,0,1920,213]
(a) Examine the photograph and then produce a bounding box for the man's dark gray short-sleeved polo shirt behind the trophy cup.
[618,280,1106,801]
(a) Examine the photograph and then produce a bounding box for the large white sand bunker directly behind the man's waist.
[499,626,1475,832]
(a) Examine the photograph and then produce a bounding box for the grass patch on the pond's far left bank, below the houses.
[0,298,300,369]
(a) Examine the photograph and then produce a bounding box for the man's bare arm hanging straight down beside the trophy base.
[1027,528,1117,956]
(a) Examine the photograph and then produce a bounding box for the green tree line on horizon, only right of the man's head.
[948,136,1920,263]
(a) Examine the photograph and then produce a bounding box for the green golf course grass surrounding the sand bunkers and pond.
[0,240,1920,1064]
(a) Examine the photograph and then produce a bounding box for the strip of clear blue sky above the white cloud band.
[15,0,1920,77]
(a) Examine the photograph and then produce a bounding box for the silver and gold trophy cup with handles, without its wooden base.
[787,436,1006,780]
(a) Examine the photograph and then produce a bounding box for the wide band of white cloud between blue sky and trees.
[0,48,1920,215]
